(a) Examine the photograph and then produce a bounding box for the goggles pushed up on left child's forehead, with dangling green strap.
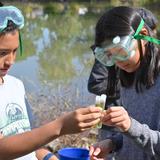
[0,6,24,54]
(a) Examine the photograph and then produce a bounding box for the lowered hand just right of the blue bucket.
[90,139,113,160]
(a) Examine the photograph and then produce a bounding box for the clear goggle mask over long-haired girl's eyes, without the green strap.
[94,36,136,66]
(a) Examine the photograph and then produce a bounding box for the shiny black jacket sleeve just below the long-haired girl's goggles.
[88,59,108,95]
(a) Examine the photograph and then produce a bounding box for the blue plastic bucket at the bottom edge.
[58,148,89,160]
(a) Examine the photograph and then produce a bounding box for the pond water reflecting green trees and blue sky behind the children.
[6,2,160,123]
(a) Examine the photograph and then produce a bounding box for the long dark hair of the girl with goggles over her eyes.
[95,6,160,95]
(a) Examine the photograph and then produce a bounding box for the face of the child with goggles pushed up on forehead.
[0,30,19,79]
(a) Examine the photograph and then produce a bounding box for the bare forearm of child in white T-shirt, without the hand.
[0,119,61,160]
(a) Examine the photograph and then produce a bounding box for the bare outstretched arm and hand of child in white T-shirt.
[0,106,101,160]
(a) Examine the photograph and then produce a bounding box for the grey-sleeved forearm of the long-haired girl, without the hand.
[125,118,160,159]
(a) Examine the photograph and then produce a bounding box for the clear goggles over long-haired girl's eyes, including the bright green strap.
[93,19,160,66]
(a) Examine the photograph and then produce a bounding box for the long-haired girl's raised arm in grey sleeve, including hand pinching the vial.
[103,106,160,159]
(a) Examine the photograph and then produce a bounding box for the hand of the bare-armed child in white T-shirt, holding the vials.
[60,106,103,135]
